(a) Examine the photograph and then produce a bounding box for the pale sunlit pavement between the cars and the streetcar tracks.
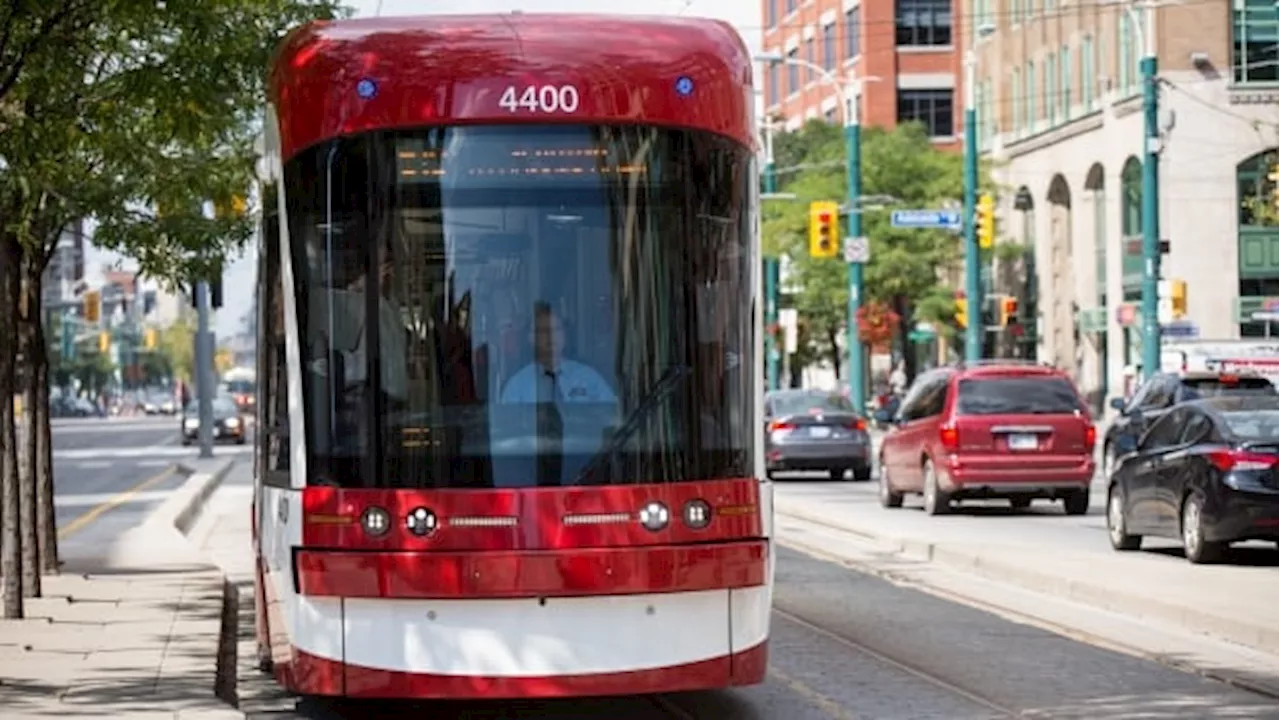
[774,497,1280,655]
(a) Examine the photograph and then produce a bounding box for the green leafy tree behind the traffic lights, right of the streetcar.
[763,120,963,373]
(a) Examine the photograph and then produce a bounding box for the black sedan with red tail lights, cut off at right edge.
[1107,395,1280,564]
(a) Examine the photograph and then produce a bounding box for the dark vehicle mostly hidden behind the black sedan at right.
[1102,372,1280,477]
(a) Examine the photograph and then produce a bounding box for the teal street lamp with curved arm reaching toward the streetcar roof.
[755,51,881,414]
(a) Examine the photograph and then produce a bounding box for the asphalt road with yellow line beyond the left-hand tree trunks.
[52,416,252,562]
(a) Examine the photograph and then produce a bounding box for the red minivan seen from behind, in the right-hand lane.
[879,360,1097,515]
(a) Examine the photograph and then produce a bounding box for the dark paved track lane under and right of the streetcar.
[241,540,1280,720]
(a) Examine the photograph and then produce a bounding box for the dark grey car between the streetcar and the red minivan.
[764,389,872,480]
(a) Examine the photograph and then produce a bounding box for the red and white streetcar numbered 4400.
[253,9,773,698]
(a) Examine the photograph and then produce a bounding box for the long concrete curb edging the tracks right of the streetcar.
[774,505,1280,653]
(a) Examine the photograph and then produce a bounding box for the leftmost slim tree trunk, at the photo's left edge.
[0,240,23,619]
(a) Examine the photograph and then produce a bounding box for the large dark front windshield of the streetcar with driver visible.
[285,126,758,488]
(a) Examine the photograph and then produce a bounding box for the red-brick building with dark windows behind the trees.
[762,0,964,150]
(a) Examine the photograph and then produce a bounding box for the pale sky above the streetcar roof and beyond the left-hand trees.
[86,0,762,337]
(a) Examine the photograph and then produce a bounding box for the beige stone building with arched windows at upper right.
[966,0,1280,404]
